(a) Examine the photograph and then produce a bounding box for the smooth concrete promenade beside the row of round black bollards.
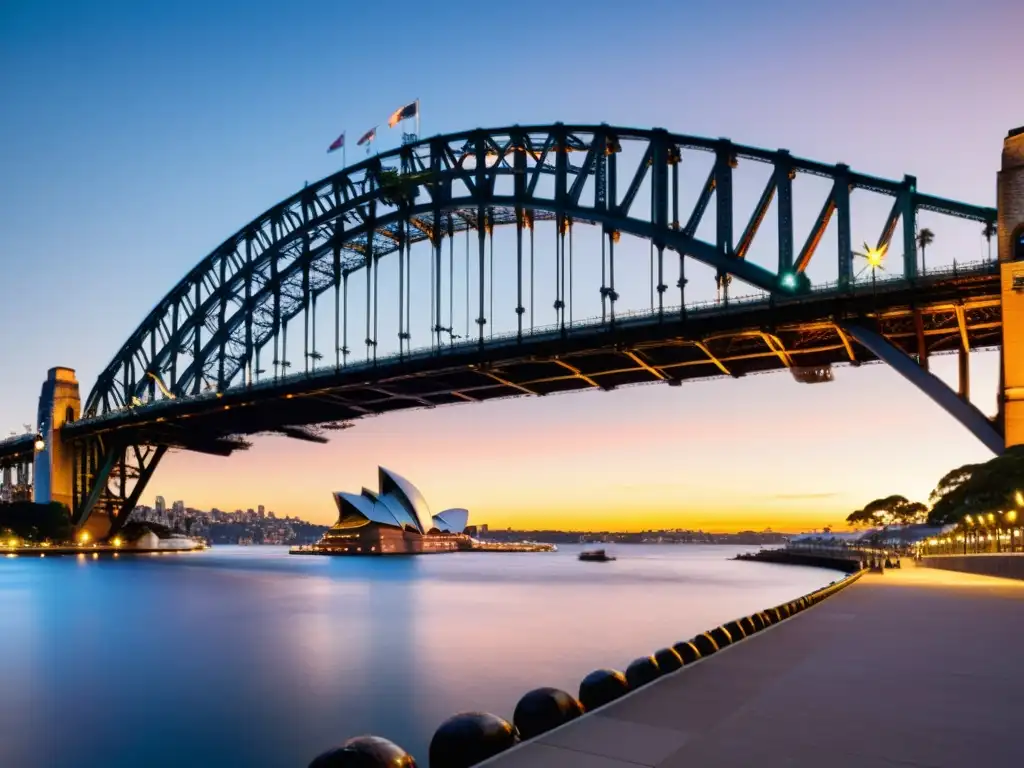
[481,561,1024,768]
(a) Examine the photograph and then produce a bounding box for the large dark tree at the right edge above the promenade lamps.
[928,445,1024,525]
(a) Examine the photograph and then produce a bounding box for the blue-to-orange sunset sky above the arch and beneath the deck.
[0,0,1024,530]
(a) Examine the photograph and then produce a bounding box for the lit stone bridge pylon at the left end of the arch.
[33,368,82,510]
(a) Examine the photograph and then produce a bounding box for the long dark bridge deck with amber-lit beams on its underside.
[63,274,1000,455]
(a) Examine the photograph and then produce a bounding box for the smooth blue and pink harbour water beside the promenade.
[0,545,839,768]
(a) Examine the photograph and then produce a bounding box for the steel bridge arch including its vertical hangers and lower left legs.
[66,123,995,536]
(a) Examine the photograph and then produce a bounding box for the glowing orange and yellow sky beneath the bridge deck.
[143,348,996,532]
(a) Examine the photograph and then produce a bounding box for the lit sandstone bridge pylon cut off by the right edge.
[996,127,1024,447]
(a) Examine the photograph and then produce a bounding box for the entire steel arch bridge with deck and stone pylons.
[6,124,1024,537]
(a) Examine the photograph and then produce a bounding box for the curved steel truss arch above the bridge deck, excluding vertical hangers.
[84,124,995,428]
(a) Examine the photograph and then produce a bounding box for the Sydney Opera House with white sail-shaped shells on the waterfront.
[309,467,470,555]
